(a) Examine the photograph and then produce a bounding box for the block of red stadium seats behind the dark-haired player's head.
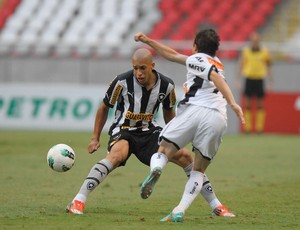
[150,0,280,58]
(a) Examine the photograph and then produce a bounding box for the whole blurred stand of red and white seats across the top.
[0,0,292,58]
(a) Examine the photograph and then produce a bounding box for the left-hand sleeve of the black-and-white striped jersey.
[103,77,123,108]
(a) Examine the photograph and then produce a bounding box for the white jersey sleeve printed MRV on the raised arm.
[186,56,216,80]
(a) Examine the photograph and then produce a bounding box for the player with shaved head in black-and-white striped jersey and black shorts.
[66,49,234,216]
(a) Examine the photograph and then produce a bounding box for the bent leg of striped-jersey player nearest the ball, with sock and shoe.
[66,140,129,214]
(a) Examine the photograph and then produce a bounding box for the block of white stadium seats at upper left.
[0,0,159,56]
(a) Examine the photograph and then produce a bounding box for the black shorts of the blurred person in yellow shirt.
[244,78,265,98]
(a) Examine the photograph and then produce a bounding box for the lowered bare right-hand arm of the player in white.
[210,70,245,125]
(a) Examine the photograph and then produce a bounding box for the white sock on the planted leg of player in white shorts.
[172,171,203,213]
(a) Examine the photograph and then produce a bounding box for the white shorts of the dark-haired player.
[160,105,227,160]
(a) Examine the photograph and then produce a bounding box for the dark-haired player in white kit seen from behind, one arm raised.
[135,29,245,222]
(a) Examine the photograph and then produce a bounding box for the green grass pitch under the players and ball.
[0,131,300,230]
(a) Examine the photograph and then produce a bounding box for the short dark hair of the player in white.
[194,29,220,56]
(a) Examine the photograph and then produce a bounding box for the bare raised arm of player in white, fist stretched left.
[134,32,187,65]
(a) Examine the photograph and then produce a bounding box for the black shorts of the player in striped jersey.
[107,127,162,166]
